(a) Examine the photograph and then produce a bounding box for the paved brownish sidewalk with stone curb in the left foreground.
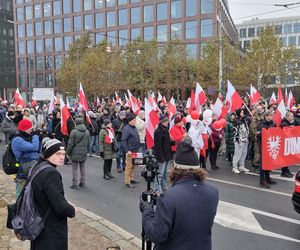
[0,170,142,250]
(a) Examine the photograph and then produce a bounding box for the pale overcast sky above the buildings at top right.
[228,0,300,24]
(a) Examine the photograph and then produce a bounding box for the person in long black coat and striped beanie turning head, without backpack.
[31,139,77,250]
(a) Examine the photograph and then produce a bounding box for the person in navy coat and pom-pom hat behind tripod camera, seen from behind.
[140,137,219,250]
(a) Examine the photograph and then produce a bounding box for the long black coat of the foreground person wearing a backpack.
[31,160,75,250]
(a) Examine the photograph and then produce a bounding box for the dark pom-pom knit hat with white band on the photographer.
[174,140,200,169]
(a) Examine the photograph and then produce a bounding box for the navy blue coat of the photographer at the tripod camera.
[143,177,219,250]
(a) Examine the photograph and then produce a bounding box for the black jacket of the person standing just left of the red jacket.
[153,124,173,162]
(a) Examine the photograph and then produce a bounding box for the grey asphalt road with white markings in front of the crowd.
[0,143,300,250]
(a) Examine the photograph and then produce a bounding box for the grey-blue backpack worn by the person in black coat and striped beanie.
[11,162,51,241]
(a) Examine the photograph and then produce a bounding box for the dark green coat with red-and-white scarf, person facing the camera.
[99,126,115,160]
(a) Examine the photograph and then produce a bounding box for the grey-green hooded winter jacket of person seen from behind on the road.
[67,124,90,162]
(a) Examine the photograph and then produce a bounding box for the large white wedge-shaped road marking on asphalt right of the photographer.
[215,201,300,243]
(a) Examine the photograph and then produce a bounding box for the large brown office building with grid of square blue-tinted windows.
[14,0,238,92]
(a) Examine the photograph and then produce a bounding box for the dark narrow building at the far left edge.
[0,0,16,99]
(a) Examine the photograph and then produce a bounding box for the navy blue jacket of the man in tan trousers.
[122,124,140,153]
